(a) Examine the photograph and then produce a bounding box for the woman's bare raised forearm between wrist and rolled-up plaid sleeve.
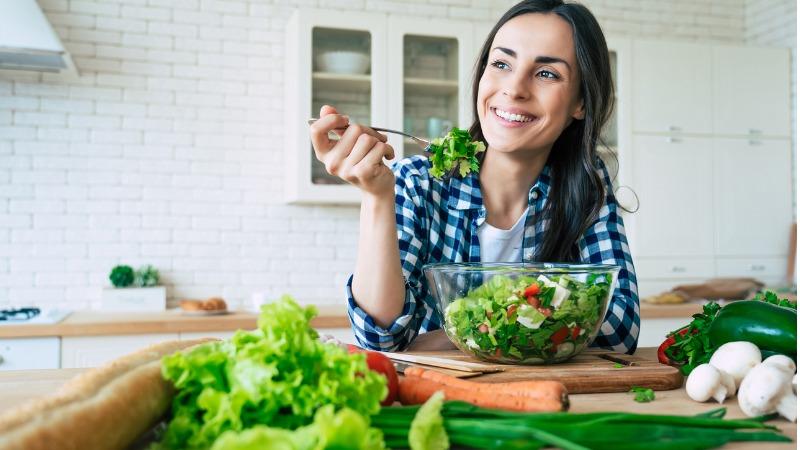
[352,192,406,328]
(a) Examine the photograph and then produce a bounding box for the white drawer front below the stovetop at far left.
[0,336,61,370]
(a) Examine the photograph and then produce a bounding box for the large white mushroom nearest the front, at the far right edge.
[739,363,797,422]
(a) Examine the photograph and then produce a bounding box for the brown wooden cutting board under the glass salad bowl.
[406,349,683,394]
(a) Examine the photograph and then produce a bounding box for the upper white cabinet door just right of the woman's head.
[631,39,713,133]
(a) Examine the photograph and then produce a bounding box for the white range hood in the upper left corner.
[0,0,76,73]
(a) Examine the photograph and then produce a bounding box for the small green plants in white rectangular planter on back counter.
[102,265,167,311]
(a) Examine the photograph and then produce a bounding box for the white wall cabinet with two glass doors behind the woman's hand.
[285,9,474,204]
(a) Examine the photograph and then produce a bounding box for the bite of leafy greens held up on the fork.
[428,128,486,178]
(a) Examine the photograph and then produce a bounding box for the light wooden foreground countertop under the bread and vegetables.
[0,348,797,450]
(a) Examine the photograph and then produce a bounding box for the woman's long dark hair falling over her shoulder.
[469,0,614,262]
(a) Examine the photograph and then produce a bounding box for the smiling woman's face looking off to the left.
[477,13,583,156]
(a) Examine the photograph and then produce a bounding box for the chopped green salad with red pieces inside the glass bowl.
[444,274,613,363]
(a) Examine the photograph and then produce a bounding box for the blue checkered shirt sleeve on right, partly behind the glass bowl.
[578,163,639,353]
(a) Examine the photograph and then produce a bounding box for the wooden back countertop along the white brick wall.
[0,303,703,338]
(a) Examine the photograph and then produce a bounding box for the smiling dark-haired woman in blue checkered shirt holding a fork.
[311,0,639,353]
